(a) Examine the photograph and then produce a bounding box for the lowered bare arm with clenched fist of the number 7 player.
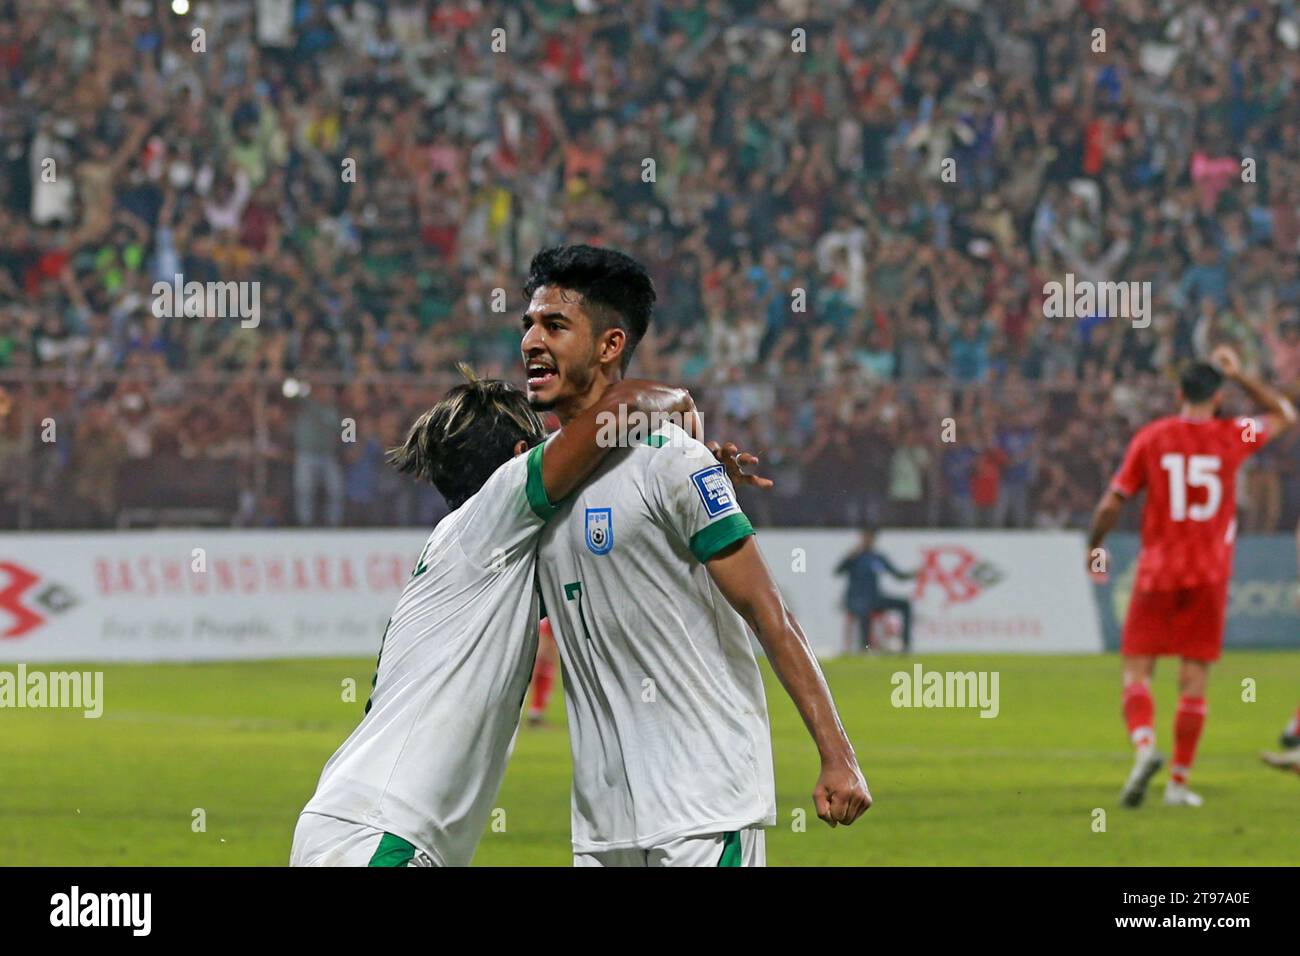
[705,536,871,826]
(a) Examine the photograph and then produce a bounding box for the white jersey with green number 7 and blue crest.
[537,424,776,853]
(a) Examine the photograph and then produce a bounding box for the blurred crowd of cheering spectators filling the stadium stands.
[0,0,1300,531]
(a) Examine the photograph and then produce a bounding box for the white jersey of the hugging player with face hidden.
[303,445,554,866]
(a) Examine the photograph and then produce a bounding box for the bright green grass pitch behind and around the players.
[0,652,1300,866]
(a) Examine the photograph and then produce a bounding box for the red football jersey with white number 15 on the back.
[1110,416,1269,591]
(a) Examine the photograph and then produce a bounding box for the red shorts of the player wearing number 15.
[1119,579,1227,661]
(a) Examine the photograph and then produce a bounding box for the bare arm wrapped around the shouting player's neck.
[542,378,698,502]
